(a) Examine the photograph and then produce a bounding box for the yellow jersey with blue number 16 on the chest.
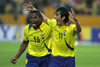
[24,22,52,57]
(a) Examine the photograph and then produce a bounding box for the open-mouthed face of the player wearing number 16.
[30,13,42,29]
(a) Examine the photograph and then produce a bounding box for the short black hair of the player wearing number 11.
[56,7,69,23]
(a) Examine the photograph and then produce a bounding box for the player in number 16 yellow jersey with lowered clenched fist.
[10,10,52,67]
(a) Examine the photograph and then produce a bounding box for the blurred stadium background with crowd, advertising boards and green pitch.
[0,0,100,67]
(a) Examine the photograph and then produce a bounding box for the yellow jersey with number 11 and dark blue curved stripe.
[47,19,76,57]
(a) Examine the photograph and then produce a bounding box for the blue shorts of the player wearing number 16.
[26,53,50,67]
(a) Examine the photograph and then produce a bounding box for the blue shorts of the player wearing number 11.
[49,56,75,67]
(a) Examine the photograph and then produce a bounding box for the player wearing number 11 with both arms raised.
[23,2,82,67]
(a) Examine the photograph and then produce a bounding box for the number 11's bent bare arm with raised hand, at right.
[69,8,82,33]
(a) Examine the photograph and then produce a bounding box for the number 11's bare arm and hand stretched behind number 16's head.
[22,2,48,23]
